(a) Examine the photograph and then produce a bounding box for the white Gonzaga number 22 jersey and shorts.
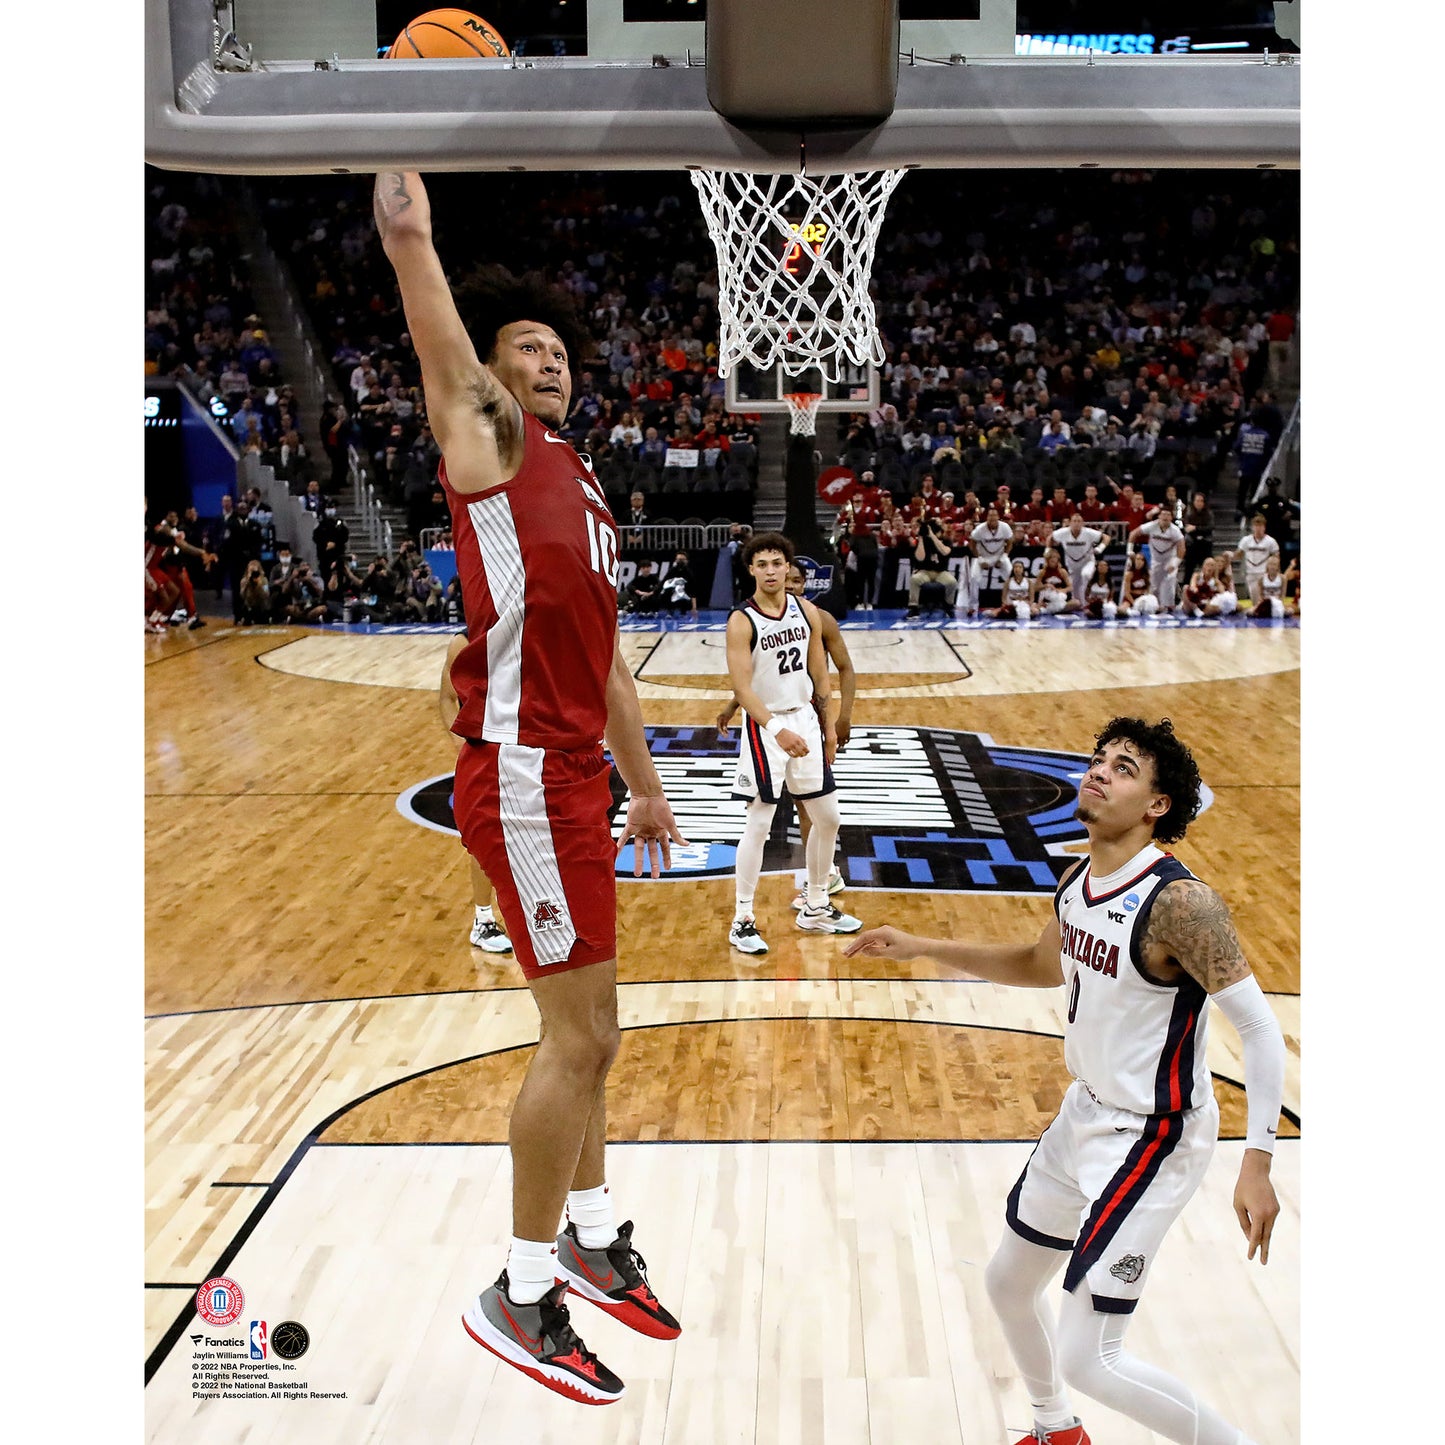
[733,594,837,803]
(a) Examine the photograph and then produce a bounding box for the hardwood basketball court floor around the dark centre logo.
[145,624,1301,1445]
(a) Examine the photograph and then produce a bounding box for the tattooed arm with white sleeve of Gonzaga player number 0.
[1143,879,1285,1264]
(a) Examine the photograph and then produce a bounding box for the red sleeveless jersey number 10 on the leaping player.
[441,412,618,750]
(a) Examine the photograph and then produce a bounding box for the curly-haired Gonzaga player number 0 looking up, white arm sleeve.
[844,718,1285,1445]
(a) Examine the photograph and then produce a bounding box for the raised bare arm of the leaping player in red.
[373,171,522,493]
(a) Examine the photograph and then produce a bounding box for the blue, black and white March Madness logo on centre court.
[397,725,1212,893]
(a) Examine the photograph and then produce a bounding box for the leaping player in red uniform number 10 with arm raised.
[374,172,683,1405]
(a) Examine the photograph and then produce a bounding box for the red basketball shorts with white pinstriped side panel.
[452,743,617,978]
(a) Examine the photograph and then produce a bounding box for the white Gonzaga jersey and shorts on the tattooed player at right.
[1007,844,1220,1315]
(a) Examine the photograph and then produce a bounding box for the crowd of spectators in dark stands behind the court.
[146,162,1299,620]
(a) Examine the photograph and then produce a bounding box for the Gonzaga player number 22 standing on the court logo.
[727,532,863,954]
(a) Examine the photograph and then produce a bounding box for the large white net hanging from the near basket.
[692,171,903,384]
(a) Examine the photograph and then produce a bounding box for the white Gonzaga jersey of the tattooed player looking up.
[1053,844,1214,1114]
